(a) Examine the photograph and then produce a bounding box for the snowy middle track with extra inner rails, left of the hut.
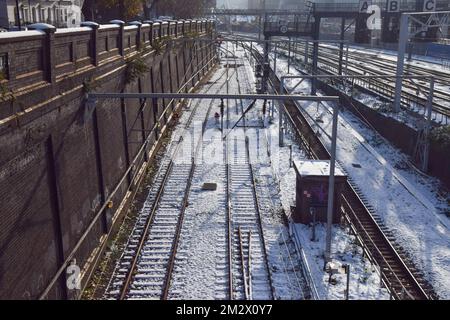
[224,52,274,300]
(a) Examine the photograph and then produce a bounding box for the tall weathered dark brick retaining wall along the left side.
[0,21,214,299]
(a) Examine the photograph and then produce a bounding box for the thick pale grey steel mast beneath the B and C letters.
[394,13,409,112]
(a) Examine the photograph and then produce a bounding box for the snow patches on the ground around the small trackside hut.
[270,107,389,300]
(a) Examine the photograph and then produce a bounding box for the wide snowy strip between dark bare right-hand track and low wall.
[270,53,450,299]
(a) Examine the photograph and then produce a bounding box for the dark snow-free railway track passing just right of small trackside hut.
[247,41,434,299]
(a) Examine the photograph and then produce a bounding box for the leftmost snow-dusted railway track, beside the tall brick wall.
[106,68,229,300]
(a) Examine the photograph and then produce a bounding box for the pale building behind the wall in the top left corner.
[0,0,84,30]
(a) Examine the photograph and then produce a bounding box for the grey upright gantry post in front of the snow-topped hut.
[325,103,339,262]
